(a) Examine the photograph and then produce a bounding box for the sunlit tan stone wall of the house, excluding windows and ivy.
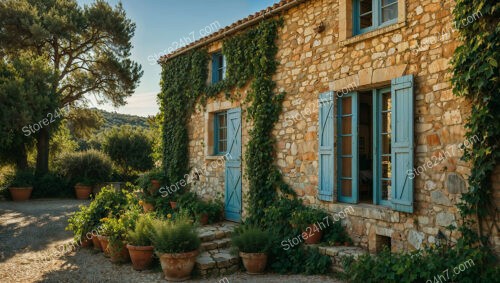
[182,0,500,251]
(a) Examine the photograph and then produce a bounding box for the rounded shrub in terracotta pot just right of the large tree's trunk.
[57,150,113,199]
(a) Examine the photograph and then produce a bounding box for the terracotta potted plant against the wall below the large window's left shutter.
[290,207,327,244]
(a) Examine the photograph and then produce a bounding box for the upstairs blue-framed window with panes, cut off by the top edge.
[353,0,398,34]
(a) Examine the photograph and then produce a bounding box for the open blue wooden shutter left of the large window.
[318,92,335,201]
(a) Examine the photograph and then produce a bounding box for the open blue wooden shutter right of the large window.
[391,75,413,212]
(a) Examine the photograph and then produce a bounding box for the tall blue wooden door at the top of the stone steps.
[224,108,242,222]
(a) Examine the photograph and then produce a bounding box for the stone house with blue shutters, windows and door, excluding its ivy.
[161,0,500,252]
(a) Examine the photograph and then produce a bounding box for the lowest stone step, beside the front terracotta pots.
[195,248,240,278]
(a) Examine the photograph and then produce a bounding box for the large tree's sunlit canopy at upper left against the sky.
[0,0,143,172]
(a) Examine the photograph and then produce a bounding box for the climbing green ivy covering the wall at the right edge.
[452,0,500,245]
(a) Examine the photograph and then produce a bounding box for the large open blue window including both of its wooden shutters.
[318,75,413,212]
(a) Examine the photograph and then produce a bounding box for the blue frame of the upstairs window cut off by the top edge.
[352,0,399,36]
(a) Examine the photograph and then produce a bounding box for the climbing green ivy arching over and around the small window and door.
[159,19,294,215]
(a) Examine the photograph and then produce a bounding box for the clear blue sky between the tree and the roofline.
[77,0,279,116]
